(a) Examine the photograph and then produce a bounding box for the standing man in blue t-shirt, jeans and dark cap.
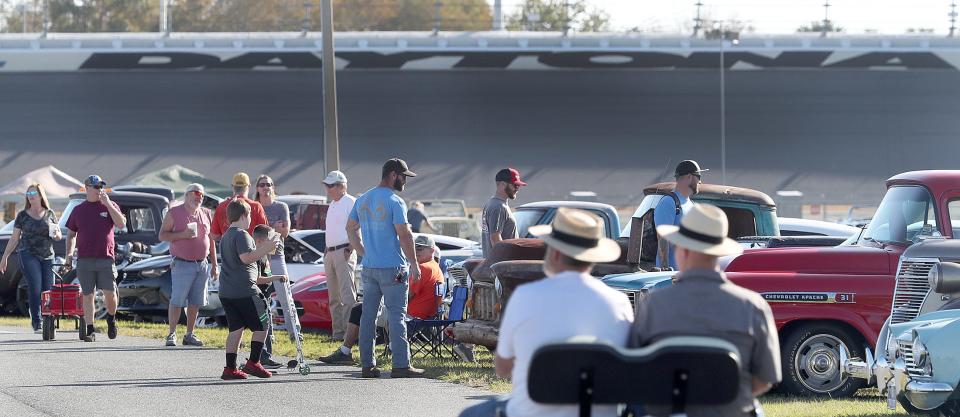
[347,158,423,378]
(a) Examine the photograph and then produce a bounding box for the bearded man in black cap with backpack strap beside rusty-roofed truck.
[653,160,709,271]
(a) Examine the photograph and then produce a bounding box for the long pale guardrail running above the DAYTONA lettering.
[0,32,960,51]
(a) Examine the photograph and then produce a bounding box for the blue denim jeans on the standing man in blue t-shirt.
[357,266,410,368]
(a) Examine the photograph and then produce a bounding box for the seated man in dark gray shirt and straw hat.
[630,204,781,417]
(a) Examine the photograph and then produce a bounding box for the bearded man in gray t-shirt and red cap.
[480,168,527,257]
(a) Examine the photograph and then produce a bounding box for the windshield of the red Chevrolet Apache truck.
[860,186,941,244]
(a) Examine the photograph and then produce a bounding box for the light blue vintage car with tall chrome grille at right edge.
[841,237,960,416]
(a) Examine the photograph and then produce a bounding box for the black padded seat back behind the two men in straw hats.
[527,336,740,417]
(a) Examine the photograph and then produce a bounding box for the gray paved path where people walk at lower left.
[0,327,492,417]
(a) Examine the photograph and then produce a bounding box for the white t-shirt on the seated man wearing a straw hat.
[497,272,633,417]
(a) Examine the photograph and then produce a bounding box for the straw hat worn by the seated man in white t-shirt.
[530,208,620,263]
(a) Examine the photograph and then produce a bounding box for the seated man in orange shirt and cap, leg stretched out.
[320,235,443,364]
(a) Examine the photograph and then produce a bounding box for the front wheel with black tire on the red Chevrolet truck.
[780,323,865,398]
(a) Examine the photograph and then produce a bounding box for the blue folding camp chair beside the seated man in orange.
[407,287,467,358]
